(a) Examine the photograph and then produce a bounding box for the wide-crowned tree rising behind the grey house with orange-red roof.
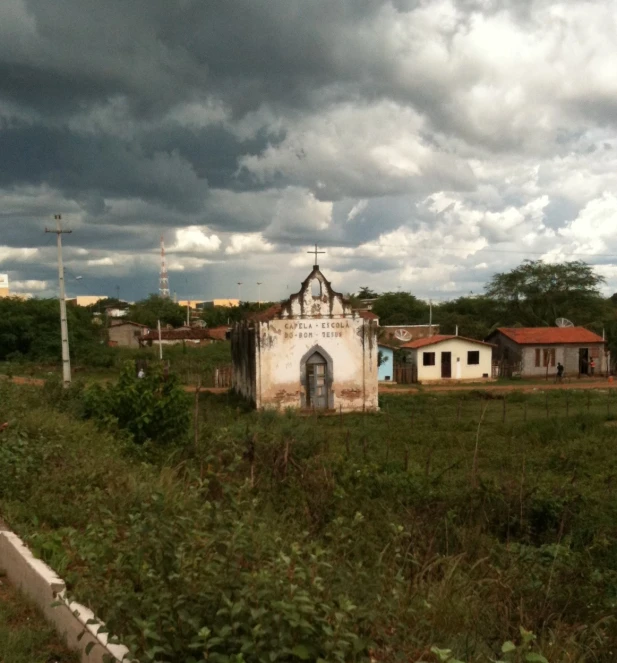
[486,260,605,326]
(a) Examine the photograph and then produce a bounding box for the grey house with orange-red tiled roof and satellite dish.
[487,327,609,378]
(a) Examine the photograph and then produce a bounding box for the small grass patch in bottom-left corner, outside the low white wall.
[0,575,79,663]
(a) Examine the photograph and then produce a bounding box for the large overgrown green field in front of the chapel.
[0,384,617,663]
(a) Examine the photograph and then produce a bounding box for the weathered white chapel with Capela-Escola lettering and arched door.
[231,265,378,412]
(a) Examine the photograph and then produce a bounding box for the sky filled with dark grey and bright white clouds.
[0,0,617,299]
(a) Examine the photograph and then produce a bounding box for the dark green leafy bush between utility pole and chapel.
[83,362,189,444]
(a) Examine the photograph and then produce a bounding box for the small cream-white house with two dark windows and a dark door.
[401,335,493,383]
